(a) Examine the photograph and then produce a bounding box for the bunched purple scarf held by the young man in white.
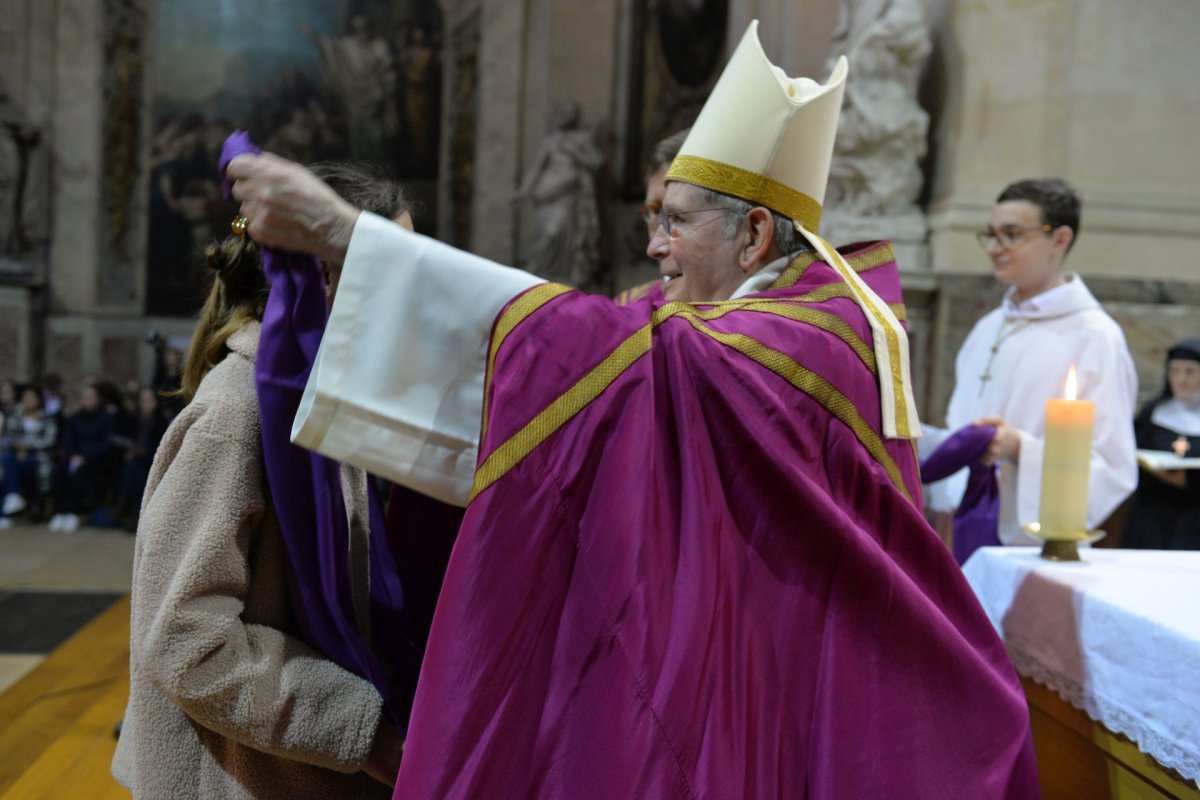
[920,425,1000,565]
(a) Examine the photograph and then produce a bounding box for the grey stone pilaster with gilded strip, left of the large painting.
[9,0,148,387]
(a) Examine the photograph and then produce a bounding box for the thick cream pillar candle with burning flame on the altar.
[1038,365,1096,539]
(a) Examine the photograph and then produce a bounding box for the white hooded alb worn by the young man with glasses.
[920,273,1138,545]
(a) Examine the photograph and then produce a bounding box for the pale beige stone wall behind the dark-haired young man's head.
[930,0,1200,279]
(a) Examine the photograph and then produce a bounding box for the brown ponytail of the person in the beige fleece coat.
[179,236,269,403]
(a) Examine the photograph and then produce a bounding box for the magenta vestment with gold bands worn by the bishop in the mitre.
[394,246,1038,800]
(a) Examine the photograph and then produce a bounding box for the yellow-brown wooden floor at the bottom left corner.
[0,597,130,800]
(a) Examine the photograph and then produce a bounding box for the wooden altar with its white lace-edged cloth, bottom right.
[962,547,1200,800]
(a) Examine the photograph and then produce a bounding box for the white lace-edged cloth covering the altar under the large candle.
[962,547,1200,782]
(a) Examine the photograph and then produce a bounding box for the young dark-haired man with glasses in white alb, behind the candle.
[920,179,1138,545]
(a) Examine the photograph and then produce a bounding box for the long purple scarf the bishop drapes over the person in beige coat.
[220,131,420,728]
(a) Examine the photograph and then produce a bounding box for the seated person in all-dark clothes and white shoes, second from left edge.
[50,384,114,534]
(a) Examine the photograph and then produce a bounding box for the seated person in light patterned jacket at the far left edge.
[0,386,58,528]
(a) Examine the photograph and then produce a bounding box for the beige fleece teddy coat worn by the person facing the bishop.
[113,324,391,800]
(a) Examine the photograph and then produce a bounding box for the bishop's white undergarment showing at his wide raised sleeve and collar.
[292,212,790,506]
